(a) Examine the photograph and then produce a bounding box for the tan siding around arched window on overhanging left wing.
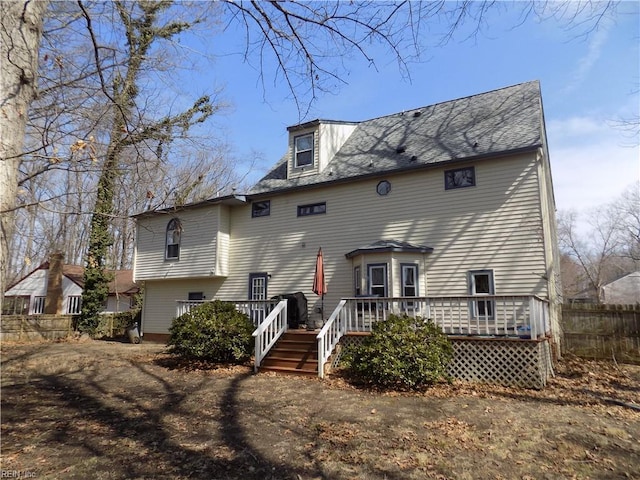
[135,205,222,281]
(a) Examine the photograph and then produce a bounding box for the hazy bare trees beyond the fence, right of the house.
[558,181,640,303]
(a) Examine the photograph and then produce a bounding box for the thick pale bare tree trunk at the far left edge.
[0,0,48,298]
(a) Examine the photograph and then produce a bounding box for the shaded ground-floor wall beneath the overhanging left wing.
[142,279,222,333]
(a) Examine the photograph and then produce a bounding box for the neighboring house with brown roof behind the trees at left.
[2,257,140,315]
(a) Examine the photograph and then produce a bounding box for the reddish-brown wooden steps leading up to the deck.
[259,330,318,376]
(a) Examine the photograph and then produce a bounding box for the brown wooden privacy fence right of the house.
[562,304,640,364]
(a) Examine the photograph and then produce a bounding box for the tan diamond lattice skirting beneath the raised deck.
[332,334,553,389]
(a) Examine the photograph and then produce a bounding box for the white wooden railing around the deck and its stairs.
[176,295,550,378]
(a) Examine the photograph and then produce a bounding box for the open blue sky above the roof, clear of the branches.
[182,1,640,216]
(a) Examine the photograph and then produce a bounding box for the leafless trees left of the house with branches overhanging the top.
[0,0,615,325]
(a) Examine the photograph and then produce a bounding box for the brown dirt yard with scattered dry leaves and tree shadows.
[1,341,640,480]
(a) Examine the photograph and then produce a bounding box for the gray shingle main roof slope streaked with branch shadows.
[249,81,544,195]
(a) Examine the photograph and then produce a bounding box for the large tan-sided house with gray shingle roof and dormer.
[134,82,559,346]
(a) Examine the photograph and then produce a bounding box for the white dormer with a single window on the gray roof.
[287,120,358,178]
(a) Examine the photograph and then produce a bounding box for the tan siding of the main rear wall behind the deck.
[218,155,547,326]
